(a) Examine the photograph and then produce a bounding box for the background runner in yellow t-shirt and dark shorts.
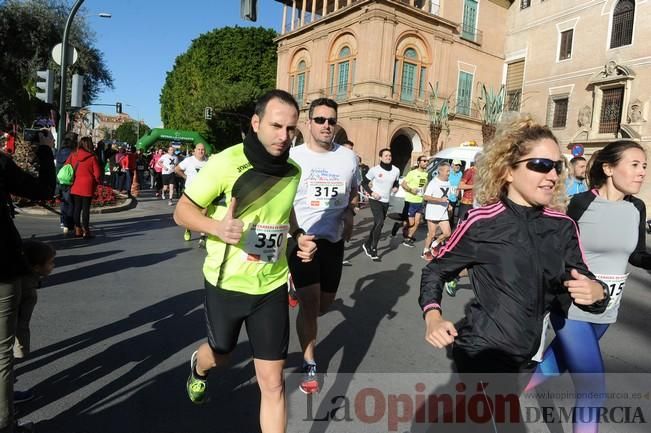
[401,156,428,248]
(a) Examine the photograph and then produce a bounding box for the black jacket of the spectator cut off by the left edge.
[0,146,56,281]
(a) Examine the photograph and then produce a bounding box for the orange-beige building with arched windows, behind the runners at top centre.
[277,0,510,170]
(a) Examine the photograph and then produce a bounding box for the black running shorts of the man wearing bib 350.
[204,281,289,361]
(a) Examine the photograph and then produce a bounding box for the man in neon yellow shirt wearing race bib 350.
[174,90,316,433]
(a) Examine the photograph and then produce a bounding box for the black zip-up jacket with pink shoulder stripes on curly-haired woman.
[418,199,608,364]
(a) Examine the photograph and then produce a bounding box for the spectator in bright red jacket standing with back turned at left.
[66,137,102,239]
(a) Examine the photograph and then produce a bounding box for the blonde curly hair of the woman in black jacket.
[475,113,567,212]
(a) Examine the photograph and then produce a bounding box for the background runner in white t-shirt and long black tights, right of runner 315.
[362,149,400,260]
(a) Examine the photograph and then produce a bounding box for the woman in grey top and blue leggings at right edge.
[527,141,651,433]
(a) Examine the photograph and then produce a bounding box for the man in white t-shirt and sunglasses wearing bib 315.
[289,98,358,394]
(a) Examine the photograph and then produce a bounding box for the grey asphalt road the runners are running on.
[10,193,651,433]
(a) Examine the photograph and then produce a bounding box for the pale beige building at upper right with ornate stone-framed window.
[504,0,651,205]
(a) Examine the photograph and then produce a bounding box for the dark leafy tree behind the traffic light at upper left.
[0,0,113,127]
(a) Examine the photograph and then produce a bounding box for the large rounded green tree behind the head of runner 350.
[160,27,276,149]
